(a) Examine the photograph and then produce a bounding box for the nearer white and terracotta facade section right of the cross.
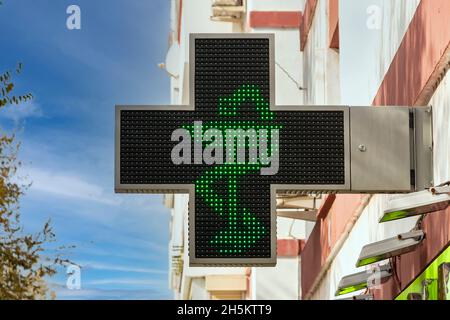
[301,0,450,299]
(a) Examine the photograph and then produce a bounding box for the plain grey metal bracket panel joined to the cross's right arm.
[350,107,414,192]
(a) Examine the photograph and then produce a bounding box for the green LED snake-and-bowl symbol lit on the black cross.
[185,84,281,255]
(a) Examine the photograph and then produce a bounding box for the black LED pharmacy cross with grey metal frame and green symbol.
[115,34,426,266]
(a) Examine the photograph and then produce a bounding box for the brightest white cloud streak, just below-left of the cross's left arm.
[28,168,121,205]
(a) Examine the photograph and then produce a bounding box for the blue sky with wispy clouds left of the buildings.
[0,0,171,299]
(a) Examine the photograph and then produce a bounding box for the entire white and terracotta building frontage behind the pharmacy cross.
[162,0,450,299]
